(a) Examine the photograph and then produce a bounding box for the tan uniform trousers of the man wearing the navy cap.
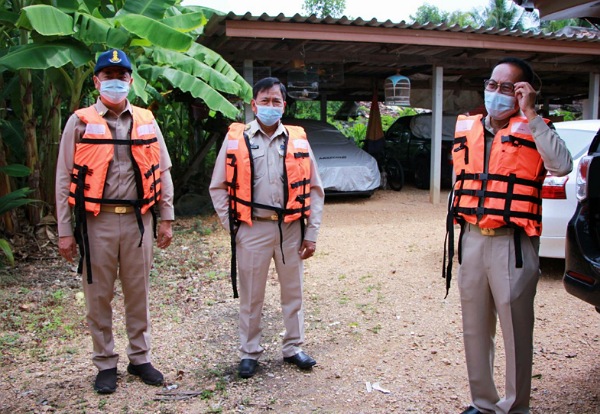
[83,212,153,370]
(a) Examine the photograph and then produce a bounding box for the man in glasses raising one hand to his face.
[445,58,573,414]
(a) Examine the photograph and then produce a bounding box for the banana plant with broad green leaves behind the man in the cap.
[0,0,252,222]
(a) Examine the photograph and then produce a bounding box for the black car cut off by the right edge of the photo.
[563,130,600,312]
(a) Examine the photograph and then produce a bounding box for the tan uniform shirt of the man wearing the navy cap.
[56,99,175,237]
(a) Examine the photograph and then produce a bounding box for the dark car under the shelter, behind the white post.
[384,113,456,189]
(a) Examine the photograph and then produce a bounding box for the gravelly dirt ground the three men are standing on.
[0,187,600,414]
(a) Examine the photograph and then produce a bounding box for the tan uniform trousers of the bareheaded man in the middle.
[236,220,304,359]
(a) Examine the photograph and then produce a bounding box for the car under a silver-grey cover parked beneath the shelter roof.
[282,118,381,196]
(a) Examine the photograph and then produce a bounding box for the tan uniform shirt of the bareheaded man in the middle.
[210,121,325,242]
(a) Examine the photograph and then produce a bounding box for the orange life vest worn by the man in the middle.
[225,123,310,225]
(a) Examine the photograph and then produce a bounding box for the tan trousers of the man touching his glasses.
[458,225,539,413]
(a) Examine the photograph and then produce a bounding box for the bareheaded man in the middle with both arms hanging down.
[210,78,324,378]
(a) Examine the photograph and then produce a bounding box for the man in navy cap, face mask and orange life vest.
[56,49,174,394]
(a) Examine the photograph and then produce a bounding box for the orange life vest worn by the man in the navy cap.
[69,106,160,215]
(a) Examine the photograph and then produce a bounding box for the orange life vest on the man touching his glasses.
[452,115,549,236]
